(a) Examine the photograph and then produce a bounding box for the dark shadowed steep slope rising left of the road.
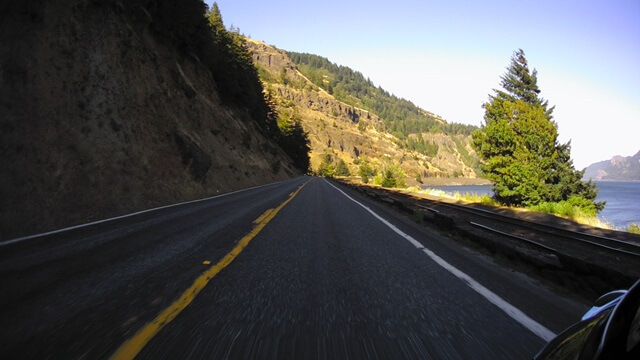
[0,0,299,239]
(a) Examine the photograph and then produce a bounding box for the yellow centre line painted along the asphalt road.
[111,180,309,360]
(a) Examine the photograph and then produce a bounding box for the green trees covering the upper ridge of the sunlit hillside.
[288,52,476,139]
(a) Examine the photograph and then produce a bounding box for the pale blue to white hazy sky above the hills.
[207,0,640,168]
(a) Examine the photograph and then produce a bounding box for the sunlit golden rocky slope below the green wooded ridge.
[247,39,477,179]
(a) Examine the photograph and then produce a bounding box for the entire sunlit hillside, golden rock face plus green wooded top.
[247,39,478,183]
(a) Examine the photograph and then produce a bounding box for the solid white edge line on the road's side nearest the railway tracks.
[325,180,556,342]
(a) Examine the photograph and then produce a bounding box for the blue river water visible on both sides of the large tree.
[425,181,640,229]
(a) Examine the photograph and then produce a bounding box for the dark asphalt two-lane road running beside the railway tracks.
[0,177,584,359]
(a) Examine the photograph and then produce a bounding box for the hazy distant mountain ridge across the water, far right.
[583,151,640,181]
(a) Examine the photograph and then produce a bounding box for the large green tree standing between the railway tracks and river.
[472,50,604,214]
